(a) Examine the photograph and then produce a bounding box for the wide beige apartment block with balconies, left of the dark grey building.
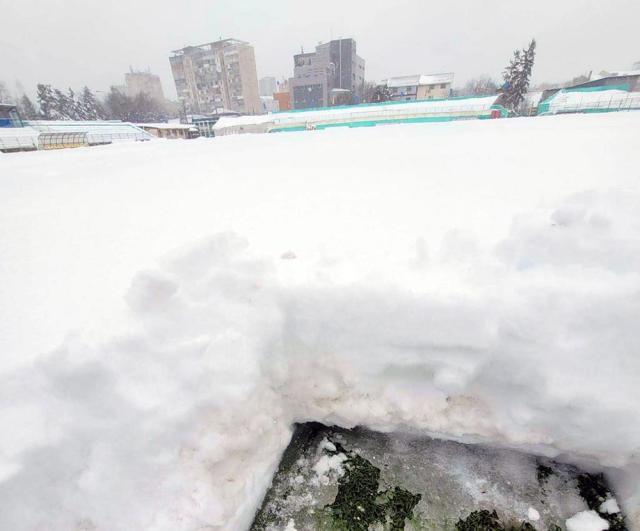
[169,39,262,114]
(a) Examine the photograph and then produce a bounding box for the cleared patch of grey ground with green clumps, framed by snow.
[251,424,627,531]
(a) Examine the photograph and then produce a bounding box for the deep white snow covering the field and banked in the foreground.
[0,113,640,531]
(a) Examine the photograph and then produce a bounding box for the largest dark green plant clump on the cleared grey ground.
[327,442,422,531]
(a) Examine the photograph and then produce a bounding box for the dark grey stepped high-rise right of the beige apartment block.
[289,39,364,109]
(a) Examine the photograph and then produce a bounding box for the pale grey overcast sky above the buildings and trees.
[0,0,640,98]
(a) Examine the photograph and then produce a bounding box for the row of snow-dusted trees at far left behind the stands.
[0,83,169,123]
